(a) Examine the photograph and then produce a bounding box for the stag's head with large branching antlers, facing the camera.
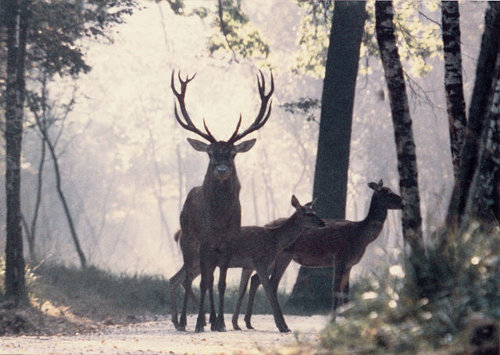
[171,71,274,180]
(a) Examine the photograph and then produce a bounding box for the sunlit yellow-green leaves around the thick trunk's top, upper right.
[293,0,442,78]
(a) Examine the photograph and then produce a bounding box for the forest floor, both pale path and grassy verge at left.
[0,266,329,354]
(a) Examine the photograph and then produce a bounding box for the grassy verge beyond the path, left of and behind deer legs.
[0,259,287,334]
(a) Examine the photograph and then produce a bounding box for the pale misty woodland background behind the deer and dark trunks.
[0,0,498,316]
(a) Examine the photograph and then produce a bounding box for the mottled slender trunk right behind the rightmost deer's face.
[375,1,423,252]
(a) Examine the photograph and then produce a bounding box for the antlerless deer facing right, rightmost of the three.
[238,180,403,329]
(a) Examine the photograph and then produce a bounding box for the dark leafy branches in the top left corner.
[27,0,137,76]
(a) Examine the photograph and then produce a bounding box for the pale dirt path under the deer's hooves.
[0,315,328,355]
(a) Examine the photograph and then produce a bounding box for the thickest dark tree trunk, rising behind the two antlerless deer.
[289,1,366,311]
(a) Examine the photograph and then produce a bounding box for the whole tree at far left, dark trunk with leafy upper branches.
[0,0,135,303]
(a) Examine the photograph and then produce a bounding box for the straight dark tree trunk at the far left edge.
[2,0,29,304]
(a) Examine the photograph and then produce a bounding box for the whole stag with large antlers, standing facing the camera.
[171,71,274,332]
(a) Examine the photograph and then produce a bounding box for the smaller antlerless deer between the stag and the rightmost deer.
[170,196,325,332]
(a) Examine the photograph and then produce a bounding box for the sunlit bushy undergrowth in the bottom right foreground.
[321,226,500,353]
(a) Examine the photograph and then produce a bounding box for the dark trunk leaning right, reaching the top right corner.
[446,2,500,229]
